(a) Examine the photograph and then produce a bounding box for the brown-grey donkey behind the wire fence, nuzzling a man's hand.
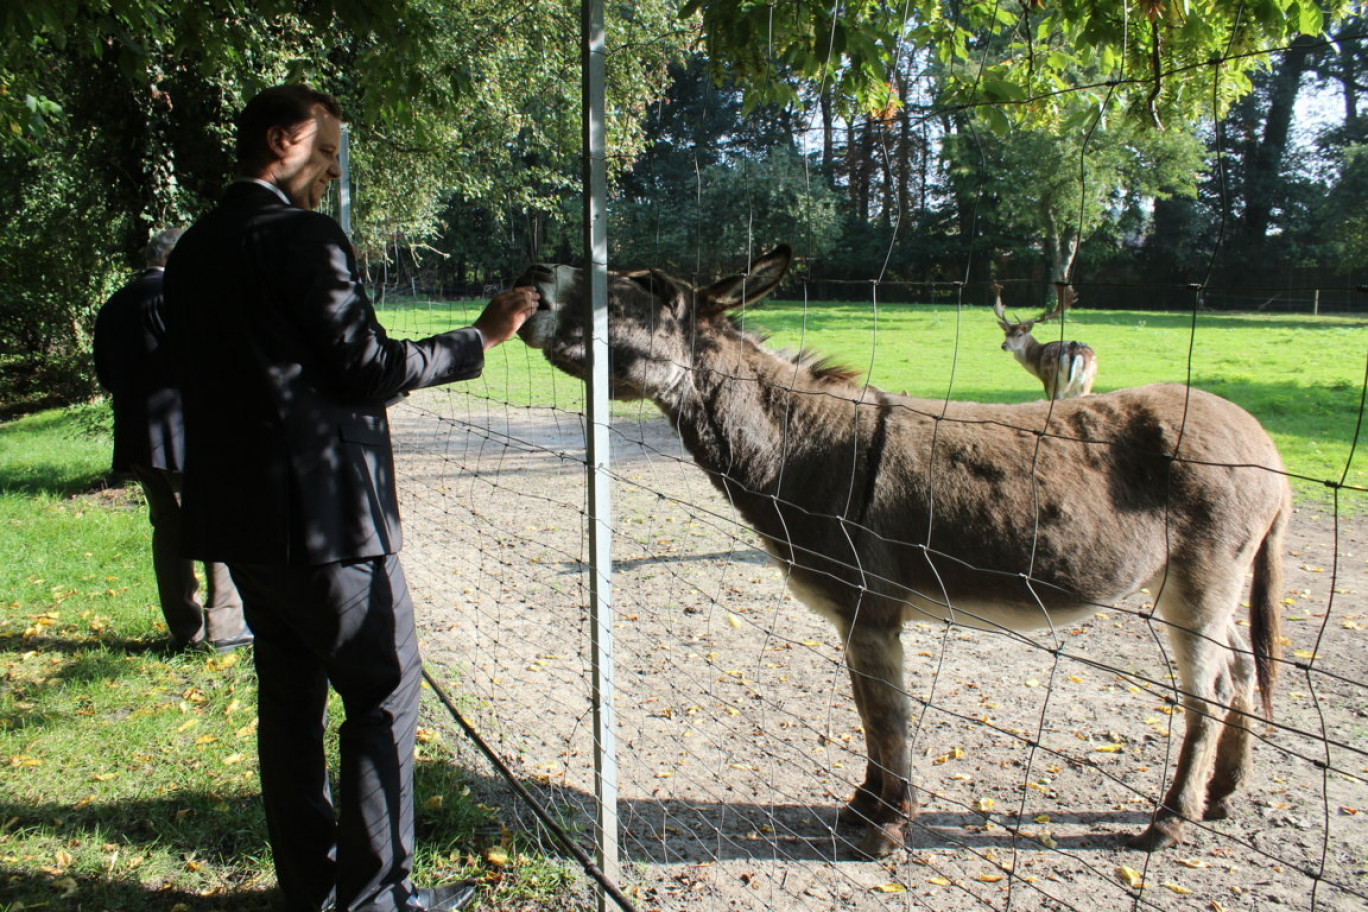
[518,246,1290,857]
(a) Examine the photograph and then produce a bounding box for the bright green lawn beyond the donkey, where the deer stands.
[382,299,1368,513]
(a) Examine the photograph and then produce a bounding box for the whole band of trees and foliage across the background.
[0,0,1368,415]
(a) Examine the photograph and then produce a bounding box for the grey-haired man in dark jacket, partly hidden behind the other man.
[94,228,252,652]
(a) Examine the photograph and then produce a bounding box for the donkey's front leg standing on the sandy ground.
[841,625,912,857]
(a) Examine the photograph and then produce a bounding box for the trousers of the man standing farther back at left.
[133,465,246,647]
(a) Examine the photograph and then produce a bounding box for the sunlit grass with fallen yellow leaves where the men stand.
[0,406,573,912]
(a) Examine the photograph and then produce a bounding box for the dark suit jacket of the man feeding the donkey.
[166,182,484,565]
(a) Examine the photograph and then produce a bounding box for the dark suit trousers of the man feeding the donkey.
[231,555,423,912]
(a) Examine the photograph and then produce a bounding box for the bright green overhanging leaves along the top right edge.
[685,0,1352,129]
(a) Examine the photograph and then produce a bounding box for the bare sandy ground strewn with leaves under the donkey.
[391,391,1368,912]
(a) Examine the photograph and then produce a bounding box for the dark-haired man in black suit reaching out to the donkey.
[166,86,536,912]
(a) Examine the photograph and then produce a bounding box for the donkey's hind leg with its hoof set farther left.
[1130,580,1234,852]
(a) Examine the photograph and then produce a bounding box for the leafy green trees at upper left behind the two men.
[0,0,692,410]
